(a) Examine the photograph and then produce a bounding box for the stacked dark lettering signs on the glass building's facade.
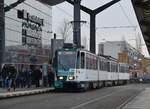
[18,10,44,47]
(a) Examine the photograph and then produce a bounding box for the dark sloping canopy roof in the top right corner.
[132,0,150,54]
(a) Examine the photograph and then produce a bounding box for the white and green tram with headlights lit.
[54,48,129,90]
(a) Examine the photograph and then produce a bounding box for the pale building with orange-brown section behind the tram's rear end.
[98,41,144,78]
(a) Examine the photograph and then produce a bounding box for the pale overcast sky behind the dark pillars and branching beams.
[52,0,149,56]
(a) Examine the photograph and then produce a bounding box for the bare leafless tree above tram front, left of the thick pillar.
[58,19,72,42]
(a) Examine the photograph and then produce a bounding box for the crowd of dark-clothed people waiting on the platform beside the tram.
[0,65,54,91]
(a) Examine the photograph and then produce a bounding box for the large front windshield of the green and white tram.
[58,51,76,71]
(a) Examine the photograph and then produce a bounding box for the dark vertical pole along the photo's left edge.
[0,0,5,71]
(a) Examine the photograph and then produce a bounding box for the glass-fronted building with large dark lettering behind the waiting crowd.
[4,0,52,66]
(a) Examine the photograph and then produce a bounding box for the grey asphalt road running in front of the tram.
[0,84,150,109]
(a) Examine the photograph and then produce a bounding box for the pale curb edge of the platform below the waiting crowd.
[0,88,54,100]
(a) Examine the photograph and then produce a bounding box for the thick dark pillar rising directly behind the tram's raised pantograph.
[73,0,81,47]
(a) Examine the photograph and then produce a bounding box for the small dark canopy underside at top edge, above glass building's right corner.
[37,0,65,6]
